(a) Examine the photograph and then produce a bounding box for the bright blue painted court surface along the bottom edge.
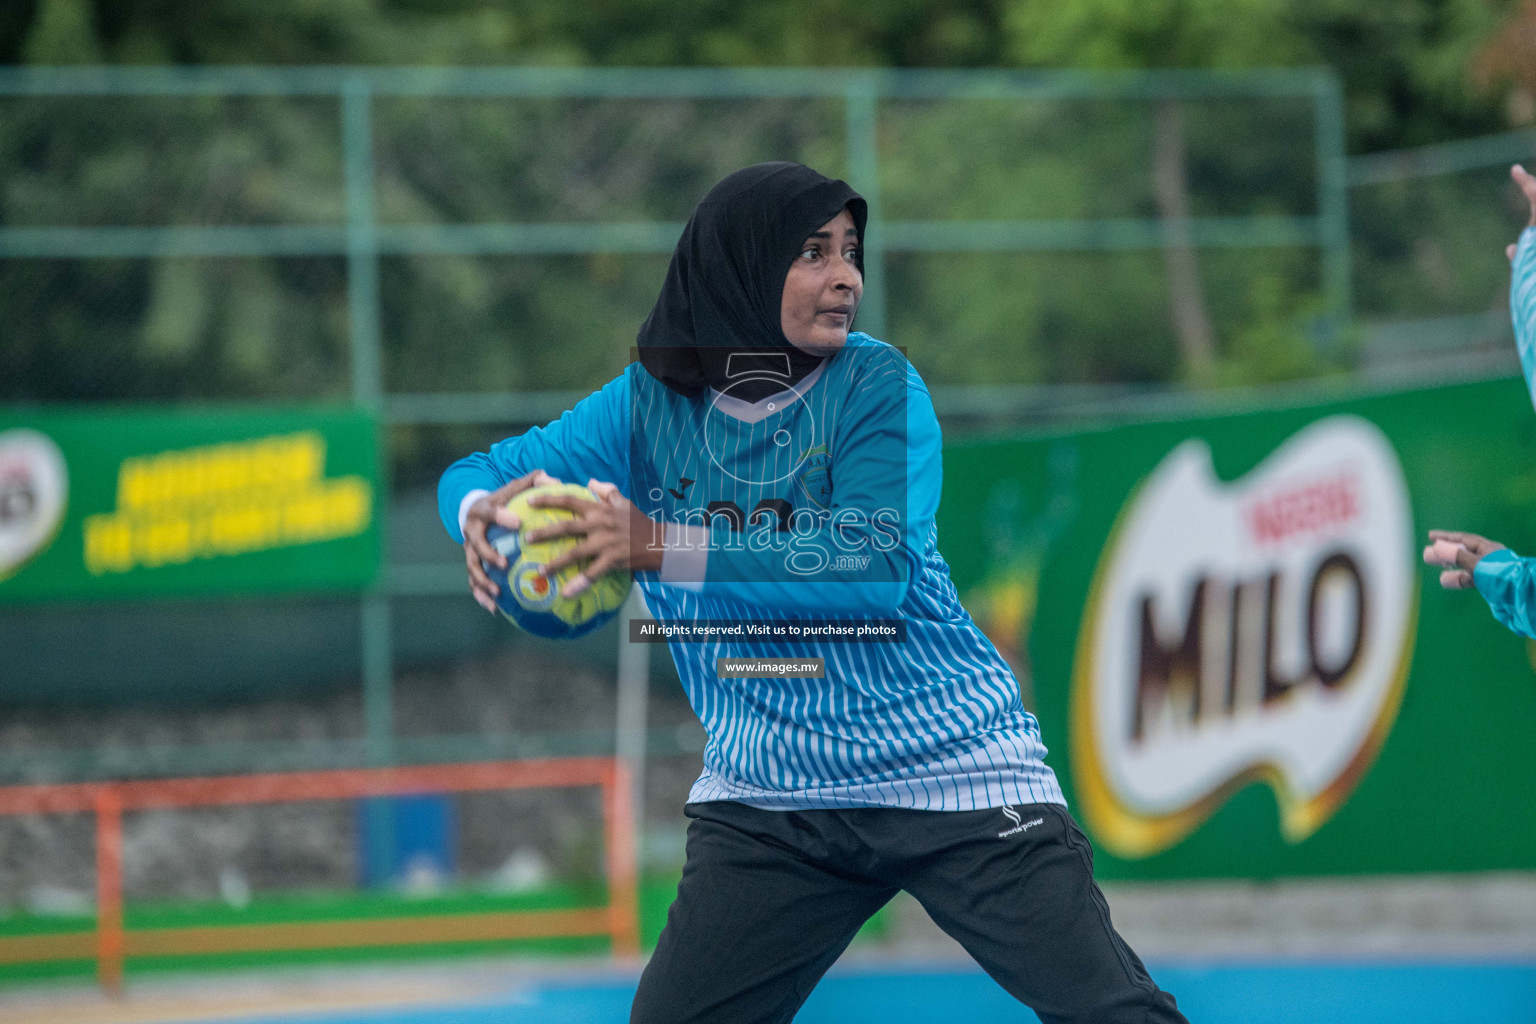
[192,963,1536,1024]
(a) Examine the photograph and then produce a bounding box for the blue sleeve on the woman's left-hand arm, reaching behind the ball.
[438,372,630,543]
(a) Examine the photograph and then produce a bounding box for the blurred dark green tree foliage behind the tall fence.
[0,0,1528,429]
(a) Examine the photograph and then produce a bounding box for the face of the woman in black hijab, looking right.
[779,210,863,355]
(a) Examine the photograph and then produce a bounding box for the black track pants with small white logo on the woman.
[630,801,1184,1024]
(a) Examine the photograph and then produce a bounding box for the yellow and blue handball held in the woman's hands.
[482,484,631,640]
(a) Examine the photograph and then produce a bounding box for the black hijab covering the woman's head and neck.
[637,161,868,402]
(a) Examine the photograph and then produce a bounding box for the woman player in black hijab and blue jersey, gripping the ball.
[439,163,1184,1024]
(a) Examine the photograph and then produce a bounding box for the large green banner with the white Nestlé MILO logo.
[940,381,1536,878]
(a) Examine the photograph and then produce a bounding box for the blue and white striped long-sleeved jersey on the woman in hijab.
[438,333,1064,811]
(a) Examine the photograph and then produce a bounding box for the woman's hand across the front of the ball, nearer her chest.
[527,481,665,597]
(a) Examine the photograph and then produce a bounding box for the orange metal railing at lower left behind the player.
[0,757,641,992]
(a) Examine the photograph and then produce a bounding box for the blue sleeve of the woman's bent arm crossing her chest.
[685,350,943,614]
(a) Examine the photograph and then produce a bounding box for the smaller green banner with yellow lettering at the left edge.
[0,408,381,603]
